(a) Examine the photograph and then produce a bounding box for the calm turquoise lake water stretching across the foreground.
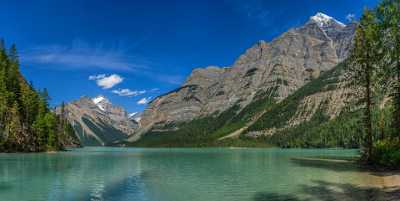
[0,147,388,201]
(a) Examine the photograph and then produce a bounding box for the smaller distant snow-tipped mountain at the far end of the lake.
[61,95,138,146]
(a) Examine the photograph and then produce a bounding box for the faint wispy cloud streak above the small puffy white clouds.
[21,40,148,71]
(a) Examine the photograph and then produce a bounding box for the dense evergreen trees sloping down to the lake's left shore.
[0,40,76,152]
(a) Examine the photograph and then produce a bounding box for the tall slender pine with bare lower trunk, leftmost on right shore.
[349,9,380,161]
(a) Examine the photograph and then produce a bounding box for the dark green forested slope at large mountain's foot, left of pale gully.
[131,89,276,147]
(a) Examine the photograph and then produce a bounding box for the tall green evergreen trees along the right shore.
[347,0,400,167]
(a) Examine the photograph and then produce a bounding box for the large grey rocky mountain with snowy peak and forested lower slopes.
[129,13,356,146]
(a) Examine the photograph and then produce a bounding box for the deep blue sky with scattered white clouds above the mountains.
[0,0,378,112]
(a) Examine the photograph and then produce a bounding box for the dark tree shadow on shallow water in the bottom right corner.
[253,181,400,201]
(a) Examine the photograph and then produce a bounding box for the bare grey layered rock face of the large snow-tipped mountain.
[134,13,356,141]
